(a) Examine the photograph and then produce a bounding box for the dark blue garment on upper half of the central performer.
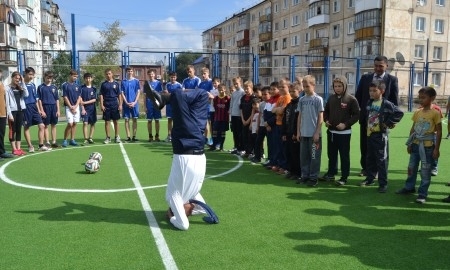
[169,89,209,154]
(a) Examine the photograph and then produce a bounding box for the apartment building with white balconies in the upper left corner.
[0,0,67,82]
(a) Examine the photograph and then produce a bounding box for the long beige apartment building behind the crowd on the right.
[203,0,450,101]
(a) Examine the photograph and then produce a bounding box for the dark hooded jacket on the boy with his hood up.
[323,76,360,131]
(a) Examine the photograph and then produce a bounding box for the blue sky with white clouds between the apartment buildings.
[54,0,261,51]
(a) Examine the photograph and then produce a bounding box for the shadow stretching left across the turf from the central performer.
[16,202,185,230]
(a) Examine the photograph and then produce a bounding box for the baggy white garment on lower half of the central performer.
[166,154,206,230]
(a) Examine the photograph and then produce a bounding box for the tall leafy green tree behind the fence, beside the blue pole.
[82,21,125,86]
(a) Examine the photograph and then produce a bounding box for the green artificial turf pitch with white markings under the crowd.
[0,118,450,269]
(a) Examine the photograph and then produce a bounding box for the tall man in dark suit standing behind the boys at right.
[355,56,398,176]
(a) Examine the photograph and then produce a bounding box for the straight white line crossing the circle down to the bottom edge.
[120,144,178,269]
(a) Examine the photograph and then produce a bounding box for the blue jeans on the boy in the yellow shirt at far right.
[405,143,434,197]
